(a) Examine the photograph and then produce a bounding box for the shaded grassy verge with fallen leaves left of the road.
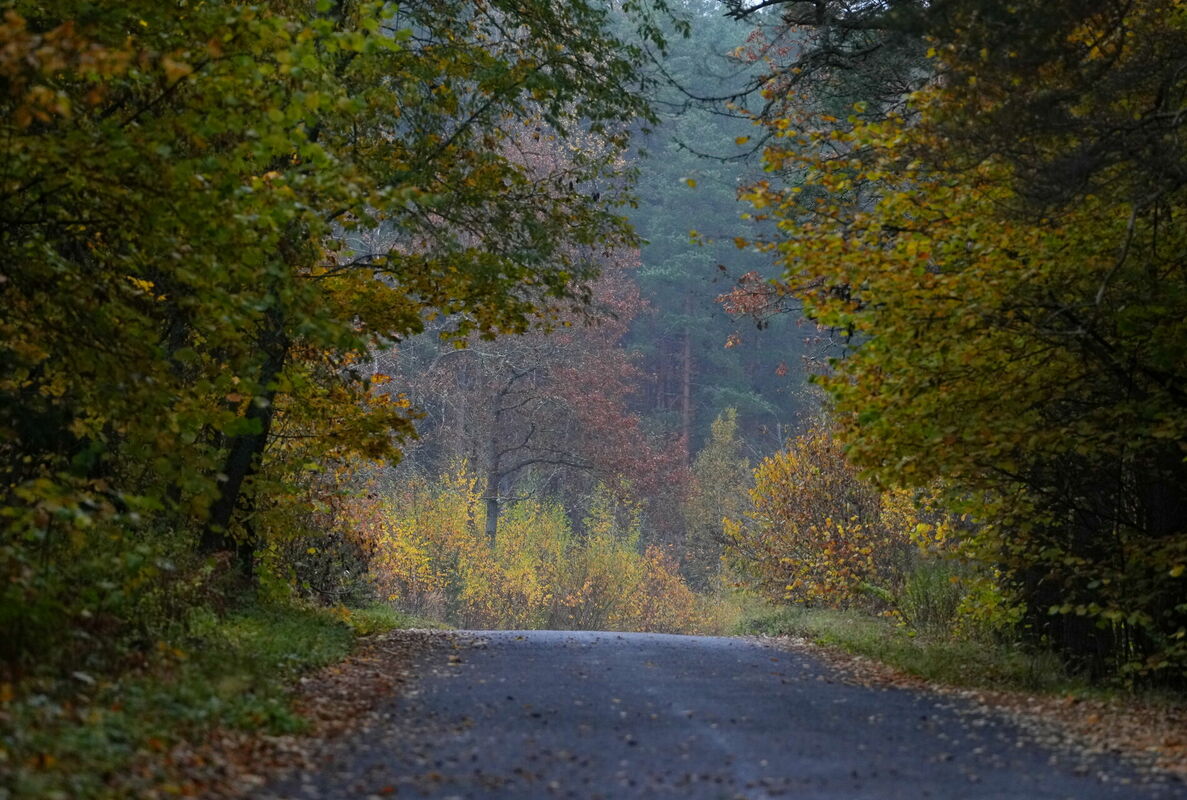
[0,604,446,800]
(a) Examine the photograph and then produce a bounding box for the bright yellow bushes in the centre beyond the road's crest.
[347,465,712,631]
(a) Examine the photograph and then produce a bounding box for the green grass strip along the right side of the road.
[738,607,1086,693]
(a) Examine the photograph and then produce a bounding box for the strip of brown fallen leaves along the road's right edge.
[747,636,1187,782]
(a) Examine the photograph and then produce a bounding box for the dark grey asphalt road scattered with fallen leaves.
[259,631,1187,800]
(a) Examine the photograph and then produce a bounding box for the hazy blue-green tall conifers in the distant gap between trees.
[629,0,807,451]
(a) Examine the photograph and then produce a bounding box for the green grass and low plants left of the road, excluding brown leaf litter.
[0,607,420,800]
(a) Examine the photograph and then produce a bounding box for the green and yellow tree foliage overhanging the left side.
[0,0,648,665]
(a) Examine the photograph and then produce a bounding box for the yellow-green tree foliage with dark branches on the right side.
[747,0,1187,681]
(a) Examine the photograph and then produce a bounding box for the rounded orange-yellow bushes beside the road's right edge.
[725,420,997,639]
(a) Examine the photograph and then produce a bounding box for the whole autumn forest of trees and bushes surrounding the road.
[0,0,1187,796]
